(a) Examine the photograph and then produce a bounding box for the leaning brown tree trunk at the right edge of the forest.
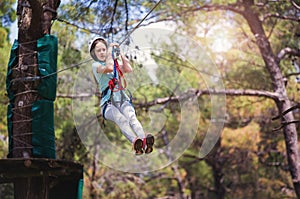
[243,0,300,198]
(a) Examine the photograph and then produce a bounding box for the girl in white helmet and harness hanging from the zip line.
[89,37,154,155]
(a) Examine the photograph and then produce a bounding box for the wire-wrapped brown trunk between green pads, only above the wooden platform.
[12,0,42,158]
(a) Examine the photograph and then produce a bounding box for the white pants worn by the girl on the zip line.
[103,101,145,143]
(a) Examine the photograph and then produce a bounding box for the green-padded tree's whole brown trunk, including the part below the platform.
[12,0,59,199]
